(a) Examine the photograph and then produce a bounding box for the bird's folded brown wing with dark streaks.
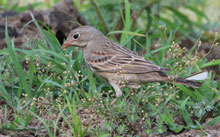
[86,44,166,73]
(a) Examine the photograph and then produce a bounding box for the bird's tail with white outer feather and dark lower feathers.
[174,71,208,88]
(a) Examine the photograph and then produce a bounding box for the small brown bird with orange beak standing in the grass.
[62,26,208,103]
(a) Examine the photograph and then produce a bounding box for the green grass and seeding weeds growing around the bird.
[0,0,220,137]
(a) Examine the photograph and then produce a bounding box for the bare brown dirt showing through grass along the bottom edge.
[0,102,220,137]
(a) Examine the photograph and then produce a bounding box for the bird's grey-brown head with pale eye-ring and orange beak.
[62,26,103,49]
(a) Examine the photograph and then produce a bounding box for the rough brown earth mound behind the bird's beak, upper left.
[0,0,86,49]
